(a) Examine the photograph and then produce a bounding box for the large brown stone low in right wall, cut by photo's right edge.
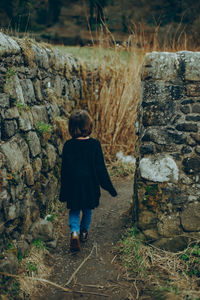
[181,202,200,232]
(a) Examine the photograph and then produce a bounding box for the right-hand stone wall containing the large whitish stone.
[134,51,200,250]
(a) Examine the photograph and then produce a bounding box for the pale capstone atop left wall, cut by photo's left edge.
[0,32,21,55]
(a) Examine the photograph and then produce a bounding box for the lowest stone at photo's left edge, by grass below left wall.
[0,252,18,274]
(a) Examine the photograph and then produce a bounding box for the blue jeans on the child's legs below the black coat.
[69,209,93,233]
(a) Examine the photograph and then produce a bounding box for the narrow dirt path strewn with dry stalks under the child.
[32,180,135,300]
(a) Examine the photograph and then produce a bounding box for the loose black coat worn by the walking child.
[60,138,117,209]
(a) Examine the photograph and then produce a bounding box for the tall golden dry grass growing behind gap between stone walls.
[76,24,194,162]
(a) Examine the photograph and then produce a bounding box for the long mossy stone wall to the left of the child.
[0,33,83,251]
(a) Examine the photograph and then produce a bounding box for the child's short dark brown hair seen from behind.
[69,109,93,138]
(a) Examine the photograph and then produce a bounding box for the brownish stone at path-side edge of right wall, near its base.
[137,210,157,229]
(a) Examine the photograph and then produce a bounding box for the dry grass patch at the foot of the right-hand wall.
[117,229,200,300]
